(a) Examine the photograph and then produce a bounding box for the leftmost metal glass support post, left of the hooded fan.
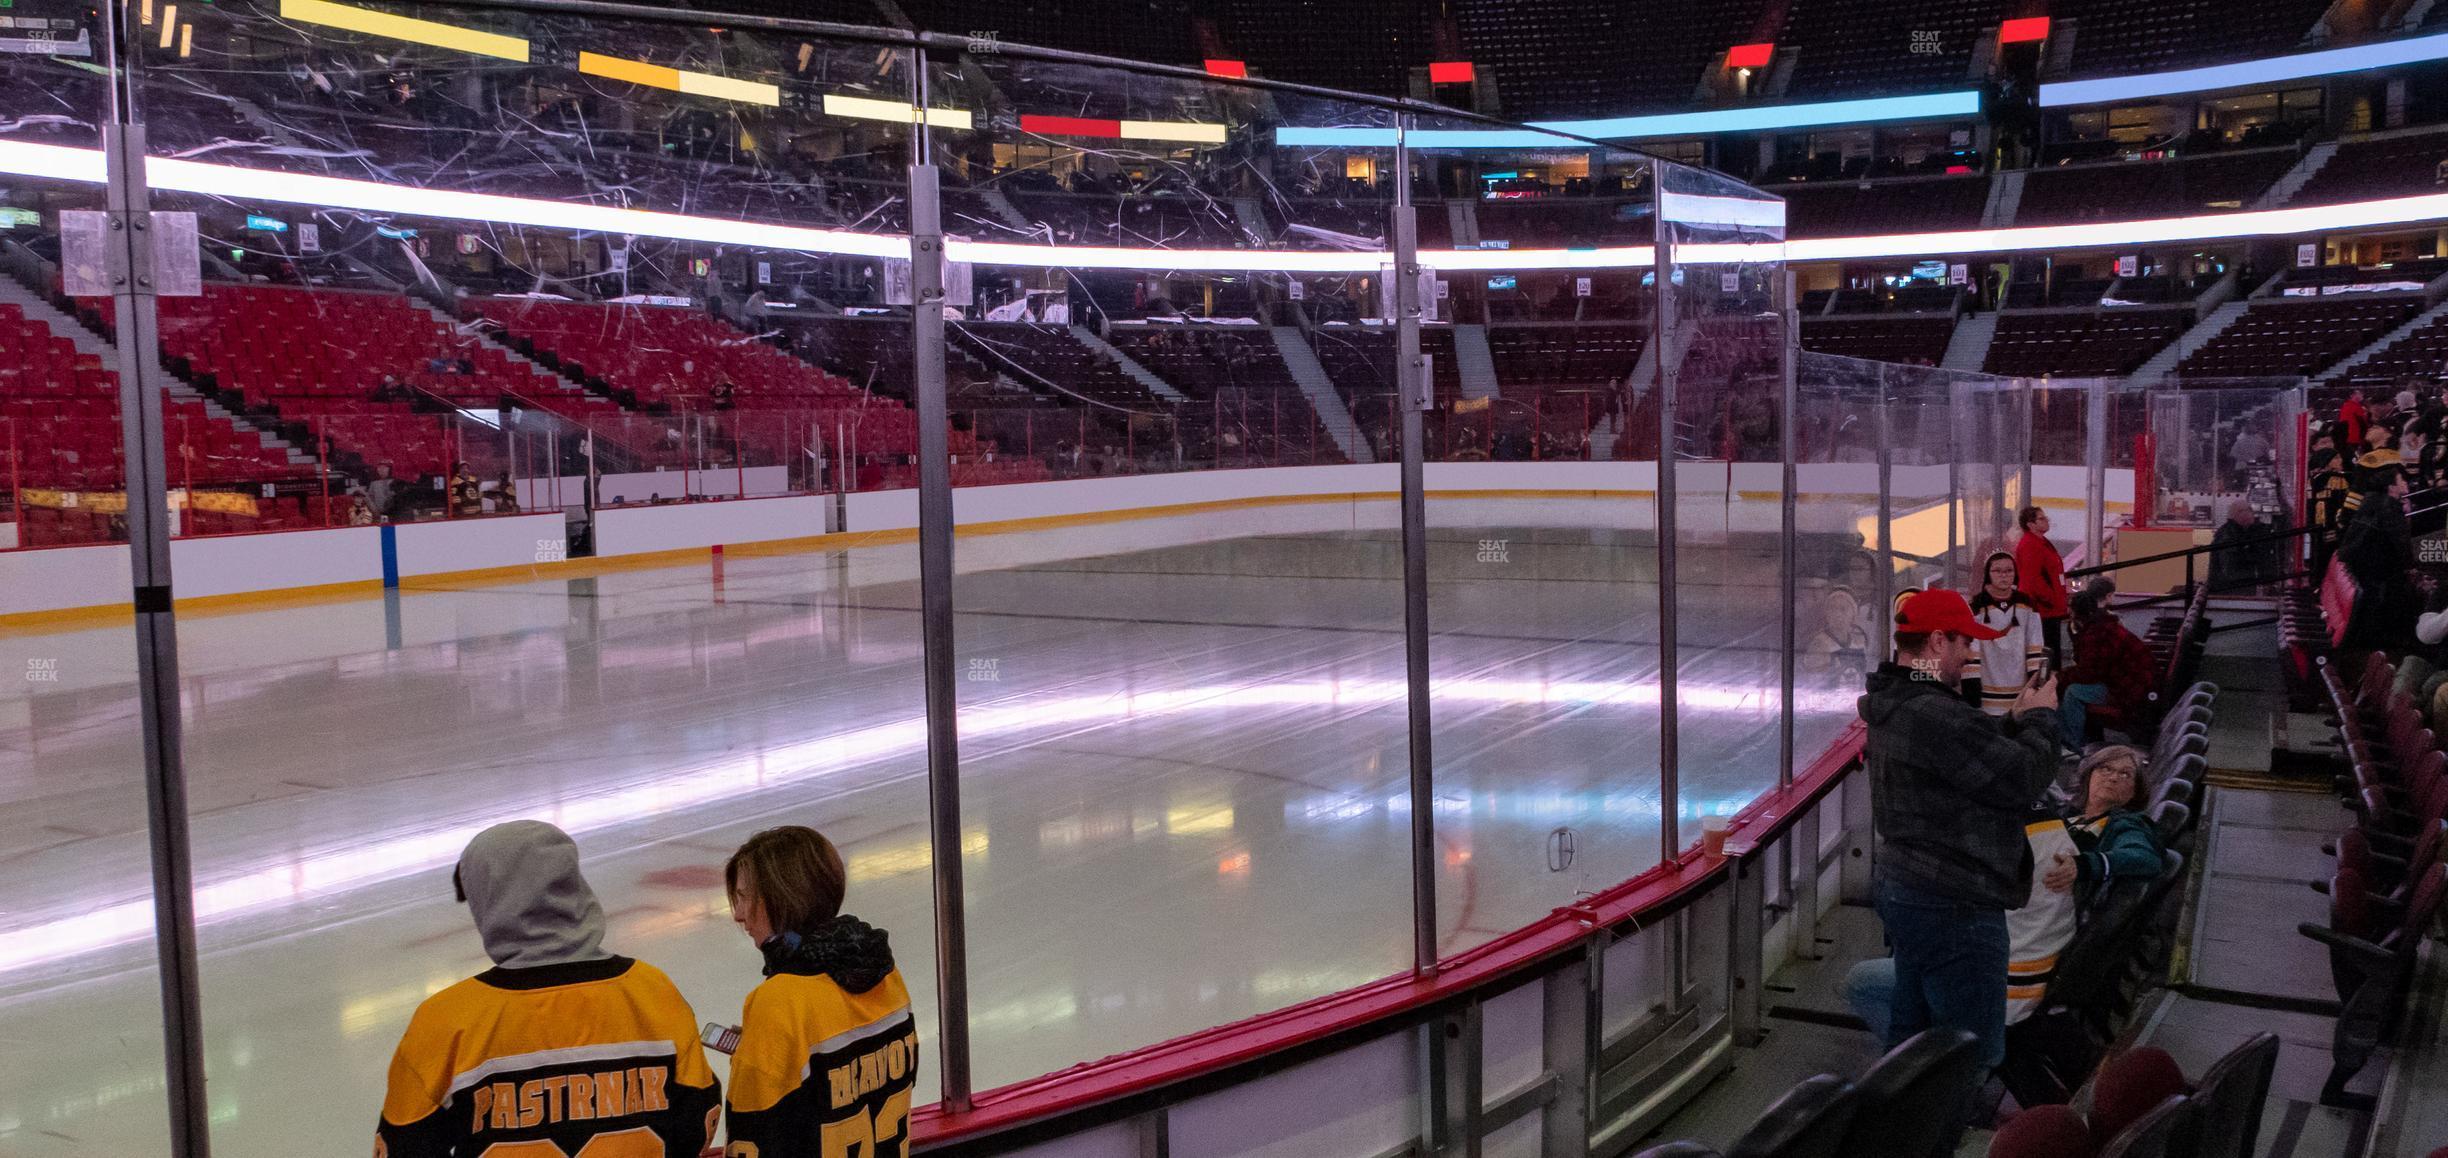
[100,5,213,1158]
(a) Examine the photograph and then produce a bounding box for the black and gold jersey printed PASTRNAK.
[375,957,722,1158]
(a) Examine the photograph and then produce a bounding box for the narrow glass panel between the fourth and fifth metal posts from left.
[1657,164,1812,847]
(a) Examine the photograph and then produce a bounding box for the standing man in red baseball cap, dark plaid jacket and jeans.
[1860,590,2056,1065]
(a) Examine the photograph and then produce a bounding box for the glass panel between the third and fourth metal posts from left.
[1388,118,1662,955]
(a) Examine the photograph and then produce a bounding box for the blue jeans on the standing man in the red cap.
[1875,881,2007,1067]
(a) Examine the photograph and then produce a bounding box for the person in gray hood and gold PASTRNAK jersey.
[375,820,722,1158]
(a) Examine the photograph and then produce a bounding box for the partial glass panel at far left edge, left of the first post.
[0,5,170,1153]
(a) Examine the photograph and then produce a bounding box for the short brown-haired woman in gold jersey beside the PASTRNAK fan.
[722,825,918,1158]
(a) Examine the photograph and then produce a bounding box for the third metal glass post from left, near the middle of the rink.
[1390,113,1437,977]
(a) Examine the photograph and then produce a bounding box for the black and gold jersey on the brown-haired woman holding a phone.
[727,918,918,1158]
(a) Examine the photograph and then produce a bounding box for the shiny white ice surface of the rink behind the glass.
[0,492,1858,1156]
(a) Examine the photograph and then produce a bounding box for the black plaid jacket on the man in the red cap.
[1860,663,2059,911]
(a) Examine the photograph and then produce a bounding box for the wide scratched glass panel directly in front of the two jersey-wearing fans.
[110,2,935,1153]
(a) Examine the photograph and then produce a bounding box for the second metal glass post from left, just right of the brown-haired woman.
[911,59,969,1114]
